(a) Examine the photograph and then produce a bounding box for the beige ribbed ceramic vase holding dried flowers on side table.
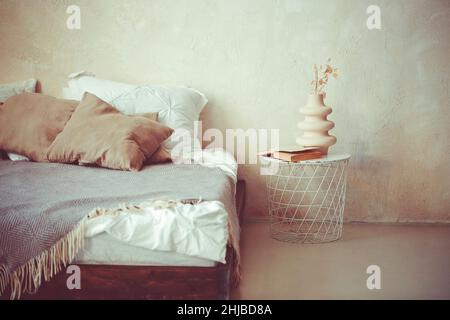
[296,94,336,154]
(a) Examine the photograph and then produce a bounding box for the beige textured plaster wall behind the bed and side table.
[0,0,450,222]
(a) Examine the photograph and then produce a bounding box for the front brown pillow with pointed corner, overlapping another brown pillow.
[47,92,173,171]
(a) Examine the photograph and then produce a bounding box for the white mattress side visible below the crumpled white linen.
[74,233,216,267]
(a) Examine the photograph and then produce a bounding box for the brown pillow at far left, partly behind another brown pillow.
[0,93,78,162]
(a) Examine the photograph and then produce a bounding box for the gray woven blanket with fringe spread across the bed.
[0,161,239,294]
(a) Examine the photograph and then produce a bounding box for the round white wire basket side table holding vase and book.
[260,154,350,243]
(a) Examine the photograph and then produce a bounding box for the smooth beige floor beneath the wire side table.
[232,222,450,299]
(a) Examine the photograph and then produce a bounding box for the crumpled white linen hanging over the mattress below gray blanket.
[85,201,228,263]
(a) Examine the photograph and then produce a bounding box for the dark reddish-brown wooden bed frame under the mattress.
[17,180,245,300]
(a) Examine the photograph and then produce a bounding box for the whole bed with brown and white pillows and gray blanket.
[0,72,244,299]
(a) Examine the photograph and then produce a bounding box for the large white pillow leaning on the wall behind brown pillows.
[63,72,208,150]
